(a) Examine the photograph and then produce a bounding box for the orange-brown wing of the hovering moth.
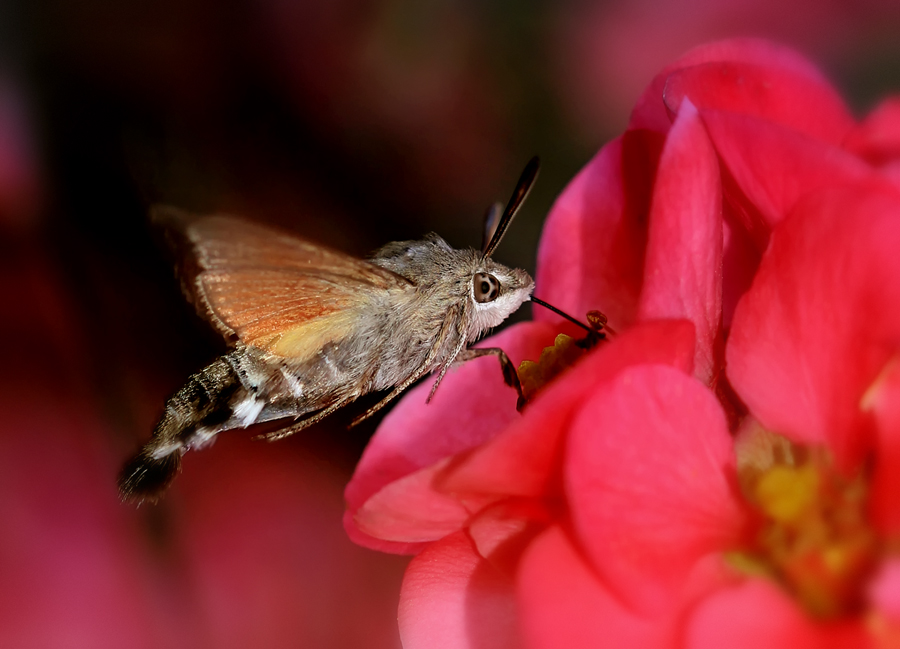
[152,207,411,361]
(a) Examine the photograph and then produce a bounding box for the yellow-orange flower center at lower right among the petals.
[732,430,882,618]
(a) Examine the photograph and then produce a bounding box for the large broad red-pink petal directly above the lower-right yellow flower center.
[727,186,900,467]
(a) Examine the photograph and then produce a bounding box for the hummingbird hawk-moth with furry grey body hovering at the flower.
[119,158,539,501]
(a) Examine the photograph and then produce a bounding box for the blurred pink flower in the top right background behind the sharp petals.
[552,0,900,139]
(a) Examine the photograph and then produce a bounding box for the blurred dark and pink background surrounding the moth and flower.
[0,0,900,648]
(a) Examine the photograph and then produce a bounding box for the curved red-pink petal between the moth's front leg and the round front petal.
[441,320,694,497]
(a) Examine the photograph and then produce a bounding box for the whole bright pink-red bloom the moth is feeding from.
[345,41,900,647]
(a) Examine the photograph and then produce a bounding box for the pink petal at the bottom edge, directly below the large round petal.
[516,527,681,649]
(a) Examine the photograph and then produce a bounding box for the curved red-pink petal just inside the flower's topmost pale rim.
[664,61,854,146]
